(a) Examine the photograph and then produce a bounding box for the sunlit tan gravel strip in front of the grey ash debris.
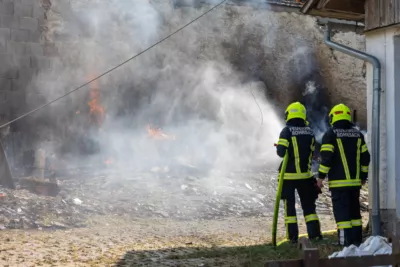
[0,215,368,266]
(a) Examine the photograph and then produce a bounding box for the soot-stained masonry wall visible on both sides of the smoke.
[0,0,366,136]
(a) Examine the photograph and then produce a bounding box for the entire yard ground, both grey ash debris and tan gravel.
[0,168,366,267]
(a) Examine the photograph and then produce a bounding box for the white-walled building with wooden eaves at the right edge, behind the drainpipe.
[301,0,400,239]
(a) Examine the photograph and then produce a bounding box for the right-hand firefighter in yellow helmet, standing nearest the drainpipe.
[317,104,370,246]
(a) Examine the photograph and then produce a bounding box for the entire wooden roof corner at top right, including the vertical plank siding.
[300,0,400,31]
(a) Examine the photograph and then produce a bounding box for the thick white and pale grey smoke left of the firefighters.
[31,0,282,180]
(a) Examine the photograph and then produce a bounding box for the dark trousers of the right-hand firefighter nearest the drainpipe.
[331,188,362,247]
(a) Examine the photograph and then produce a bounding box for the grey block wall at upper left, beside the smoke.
[0,0,56,131]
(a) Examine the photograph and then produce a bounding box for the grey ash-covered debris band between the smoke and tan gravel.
[0,162,368,229]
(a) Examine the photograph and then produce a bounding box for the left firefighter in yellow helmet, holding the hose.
[277,102,322,243]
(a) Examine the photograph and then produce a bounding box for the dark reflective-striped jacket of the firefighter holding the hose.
[277,119,315,180]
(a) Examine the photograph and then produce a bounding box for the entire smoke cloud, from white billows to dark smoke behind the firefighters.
[1,0,344,220]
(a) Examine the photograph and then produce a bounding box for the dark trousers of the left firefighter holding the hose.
[282,178,321,243]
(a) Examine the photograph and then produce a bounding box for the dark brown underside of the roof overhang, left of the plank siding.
[300,0,365,21]
